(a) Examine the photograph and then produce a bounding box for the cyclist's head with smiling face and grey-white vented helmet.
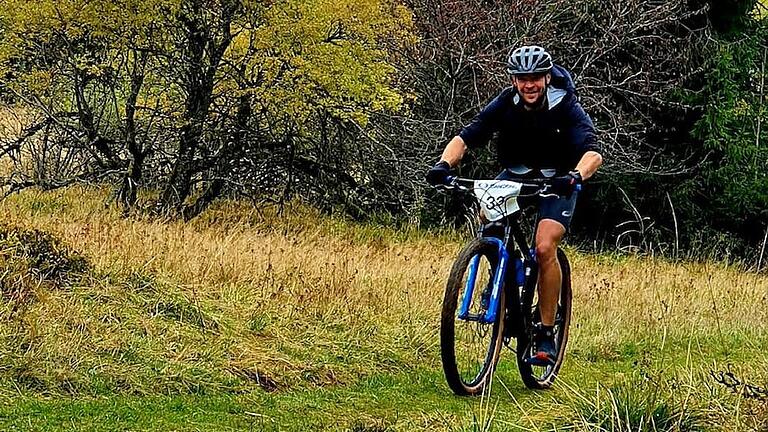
[507,45,552,107]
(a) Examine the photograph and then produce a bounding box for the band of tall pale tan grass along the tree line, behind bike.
[6,188,768,333]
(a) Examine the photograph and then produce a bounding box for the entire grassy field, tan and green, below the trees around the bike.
[0,188,768,431]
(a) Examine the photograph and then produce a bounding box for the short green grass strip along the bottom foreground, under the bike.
[0,356,760,431]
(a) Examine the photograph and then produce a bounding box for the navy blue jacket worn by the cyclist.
[459,65,600,173]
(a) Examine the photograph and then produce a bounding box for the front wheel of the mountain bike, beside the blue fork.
[440,238,504,395]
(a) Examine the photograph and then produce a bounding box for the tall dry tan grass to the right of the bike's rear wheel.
[573,256,768,335]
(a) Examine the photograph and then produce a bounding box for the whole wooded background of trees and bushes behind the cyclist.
[0,0,768,260]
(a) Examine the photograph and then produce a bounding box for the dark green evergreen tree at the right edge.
[694,14,768,236]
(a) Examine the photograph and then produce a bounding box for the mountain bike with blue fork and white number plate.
[440,177,572,395]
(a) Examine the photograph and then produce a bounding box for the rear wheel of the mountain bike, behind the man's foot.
[517,249,573,389]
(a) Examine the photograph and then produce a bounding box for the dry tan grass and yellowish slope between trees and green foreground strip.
[0,188,768,404]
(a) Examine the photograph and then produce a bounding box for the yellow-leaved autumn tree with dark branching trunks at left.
[0,0,413,217]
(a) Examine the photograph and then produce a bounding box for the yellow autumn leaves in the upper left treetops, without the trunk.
[0,0,414,127]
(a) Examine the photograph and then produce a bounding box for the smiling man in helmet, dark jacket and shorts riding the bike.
[427,46,603,366]
